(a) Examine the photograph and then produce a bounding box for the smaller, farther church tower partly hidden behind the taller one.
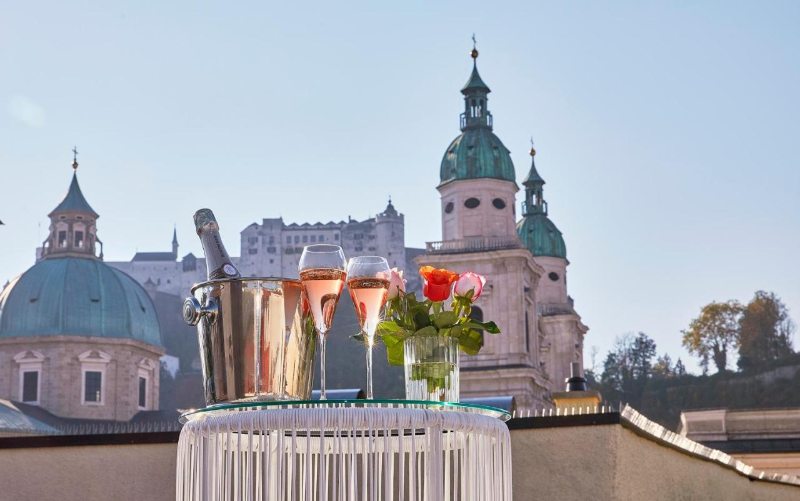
[517,142,588,391]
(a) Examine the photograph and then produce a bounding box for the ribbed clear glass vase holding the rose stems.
[403,336,459,402]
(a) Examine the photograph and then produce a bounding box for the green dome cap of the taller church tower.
[440,127,516,184]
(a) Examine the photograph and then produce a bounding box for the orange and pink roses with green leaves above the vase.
[377,266,500,365]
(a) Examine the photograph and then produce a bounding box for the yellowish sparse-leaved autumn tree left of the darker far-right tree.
[682,301,742,372]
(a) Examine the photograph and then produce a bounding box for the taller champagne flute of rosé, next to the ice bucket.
[299,244,347,400]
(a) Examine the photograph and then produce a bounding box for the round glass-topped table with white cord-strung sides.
[176,400,511,501]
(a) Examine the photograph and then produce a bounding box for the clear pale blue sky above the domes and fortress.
[0,1,800,372]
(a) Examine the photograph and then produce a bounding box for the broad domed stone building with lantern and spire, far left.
[0,161,164,421]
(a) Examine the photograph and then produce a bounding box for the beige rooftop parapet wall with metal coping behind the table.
[0,408,800,501]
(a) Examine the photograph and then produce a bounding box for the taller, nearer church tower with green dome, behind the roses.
[416,43,550,407]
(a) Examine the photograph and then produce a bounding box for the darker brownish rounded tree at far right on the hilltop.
[739,291,794,370]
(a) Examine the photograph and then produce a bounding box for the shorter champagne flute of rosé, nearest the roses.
[347,256,391,400]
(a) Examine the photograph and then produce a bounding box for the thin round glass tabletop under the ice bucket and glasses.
[180,399,511,423]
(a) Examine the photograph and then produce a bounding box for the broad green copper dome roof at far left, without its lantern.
[0,257,163,346]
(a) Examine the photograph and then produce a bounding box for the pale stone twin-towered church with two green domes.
[416,49,587,407]
